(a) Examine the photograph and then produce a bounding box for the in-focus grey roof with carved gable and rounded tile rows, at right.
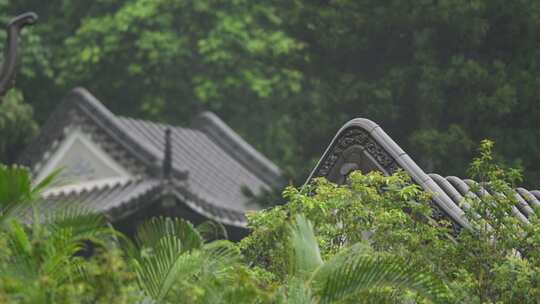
[307,118,540,228]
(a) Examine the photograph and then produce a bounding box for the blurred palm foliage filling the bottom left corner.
[0,165,140,303]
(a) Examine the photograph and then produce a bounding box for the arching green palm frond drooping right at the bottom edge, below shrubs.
[311,245,448,303]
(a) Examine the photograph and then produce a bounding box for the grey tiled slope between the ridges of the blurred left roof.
[116,117,268,211]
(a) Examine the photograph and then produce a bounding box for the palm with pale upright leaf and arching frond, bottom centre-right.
[280,215,447,303]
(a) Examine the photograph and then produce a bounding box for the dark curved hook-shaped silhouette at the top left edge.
[0,12,38,98]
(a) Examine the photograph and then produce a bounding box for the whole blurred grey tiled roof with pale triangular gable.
[21,88,283,227]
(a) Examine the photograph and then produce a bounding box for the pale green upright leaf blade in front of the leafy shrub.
[289,215,323,278]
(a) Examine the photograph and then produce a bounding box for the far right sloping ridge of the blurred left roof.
[192,111,284,186]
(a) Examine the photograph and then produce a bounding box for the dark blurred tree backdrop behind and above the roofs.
[4,0,540,185]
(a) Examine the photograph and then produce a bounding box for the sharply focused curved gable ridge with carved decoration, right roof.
[307,118,470,227]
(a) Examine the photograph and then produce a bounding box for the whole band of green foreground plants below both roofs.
[0,141,540,303]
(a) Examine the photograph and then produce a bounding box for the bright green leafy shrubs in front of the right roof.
[244,141,540,303]
